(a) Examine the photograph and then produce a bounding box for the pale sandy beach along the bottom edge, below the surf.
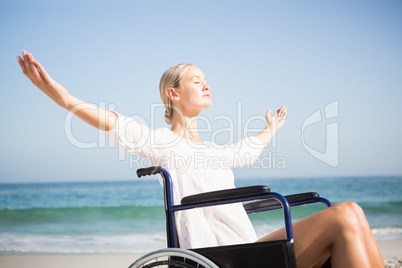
[0,239,402,268]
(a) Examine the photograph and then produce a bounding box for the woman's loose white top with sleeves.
[107,114,264,249]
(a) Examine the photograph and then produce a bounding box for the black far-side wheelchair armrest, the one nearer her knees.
[244,192,320,211]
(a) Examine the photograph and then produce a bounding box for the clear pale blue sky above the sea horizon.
[0,0,402,182]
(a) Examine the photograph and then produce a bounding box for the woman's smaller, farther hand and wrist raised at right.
[255,106,287,146]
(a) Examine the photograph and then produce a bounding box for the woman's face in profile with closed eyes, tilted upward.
[176,66,212,114]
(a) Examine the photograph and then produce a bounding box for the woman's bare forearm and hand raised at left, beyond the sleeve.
[17,50,116,131]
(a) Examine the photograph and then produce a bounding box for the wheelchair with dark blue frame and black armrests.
[129,166,331,268]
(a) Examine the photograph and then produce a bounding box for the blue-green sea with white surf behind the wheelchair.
[0,176,402,255]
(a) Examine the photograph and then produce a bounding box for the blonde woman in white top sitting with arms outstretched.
[17,51,384,267]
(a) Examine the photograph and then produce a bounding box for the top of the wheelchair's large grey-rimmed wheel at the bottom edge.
[129,248,219,268]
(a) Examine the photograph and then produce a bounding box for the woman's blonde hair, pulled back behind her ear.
[159,63,192,125]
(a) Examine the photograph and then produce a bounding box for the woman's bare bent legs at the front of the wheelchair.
[258,203,384,268]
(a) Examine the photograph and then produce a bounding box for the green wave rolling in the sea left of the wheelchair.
[0,206,165,235]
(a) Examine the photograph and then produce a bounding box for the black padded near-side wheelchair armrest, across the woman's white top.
[181,186,270,205]
